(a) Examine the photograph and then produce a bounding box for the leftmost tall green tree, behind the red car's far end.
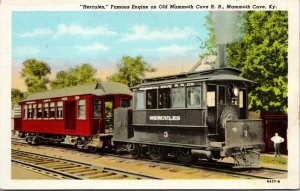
[21,59,51,93]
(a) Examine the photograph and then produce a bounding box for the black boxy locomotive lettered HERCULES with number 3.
[113,68,264,167]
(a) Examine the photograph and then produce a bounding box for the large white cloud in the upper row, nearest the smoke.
[121,25,195,41]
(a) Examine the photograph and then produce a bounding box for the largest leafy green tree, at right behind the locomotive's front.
[227,11,288,111]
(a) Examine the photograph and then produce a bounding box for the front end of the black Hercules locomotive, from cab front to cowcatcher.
[206,68,264,167]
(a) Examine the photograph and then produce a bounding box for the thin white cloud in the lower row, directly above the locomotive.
[144,44,195,54]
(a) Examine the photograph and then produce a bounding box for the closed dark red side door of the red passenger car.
[64,101,76,130]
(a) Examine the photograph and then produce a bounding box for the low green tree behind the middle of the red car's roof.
[50,64,101,89]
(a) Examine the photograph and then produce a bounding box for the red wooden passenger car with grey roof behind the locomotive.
[15,82,132,148]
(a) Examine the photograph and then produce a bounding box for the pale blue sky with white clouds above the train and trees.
[12,11,208,89]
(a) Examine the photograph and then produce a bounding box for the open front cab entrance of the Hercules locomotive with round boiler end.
[206,81,247,141]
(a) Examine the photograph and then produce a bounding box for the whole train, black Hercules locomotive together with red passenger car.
[15,54,264,168]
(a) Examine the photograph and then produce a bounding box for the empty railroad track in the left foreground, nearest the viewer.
[12,149,158,180]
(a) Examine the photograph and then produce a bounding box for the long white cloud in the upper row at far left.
[19,24,117,38]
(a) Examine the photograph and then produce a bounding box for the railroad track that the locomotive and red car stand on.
[11,137,287,179]
